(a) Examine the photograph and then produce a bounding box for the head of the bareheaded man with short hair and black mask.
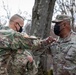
[9,14,24,33]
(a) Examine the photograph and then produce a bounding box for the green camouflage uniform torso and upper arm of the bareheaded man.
[0,27,37,75]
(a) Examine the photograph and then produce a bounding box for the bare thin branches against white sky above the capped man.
[54,0,76,31]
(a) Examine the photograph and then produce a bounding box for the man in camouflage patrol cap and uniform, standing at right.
[41,15,76,75]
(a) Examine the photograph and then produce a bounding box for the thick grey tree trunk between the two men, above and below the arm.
[30,0,56,75]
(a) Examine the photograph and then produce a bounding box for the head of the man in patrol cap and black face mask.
[52,15,71,37]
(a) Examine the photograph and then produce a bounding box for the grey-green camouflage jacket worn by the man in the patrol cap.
[51,32,76,75]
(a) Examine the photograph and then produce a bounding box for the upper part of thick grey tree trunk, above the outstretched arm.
[30,0,56,39]
